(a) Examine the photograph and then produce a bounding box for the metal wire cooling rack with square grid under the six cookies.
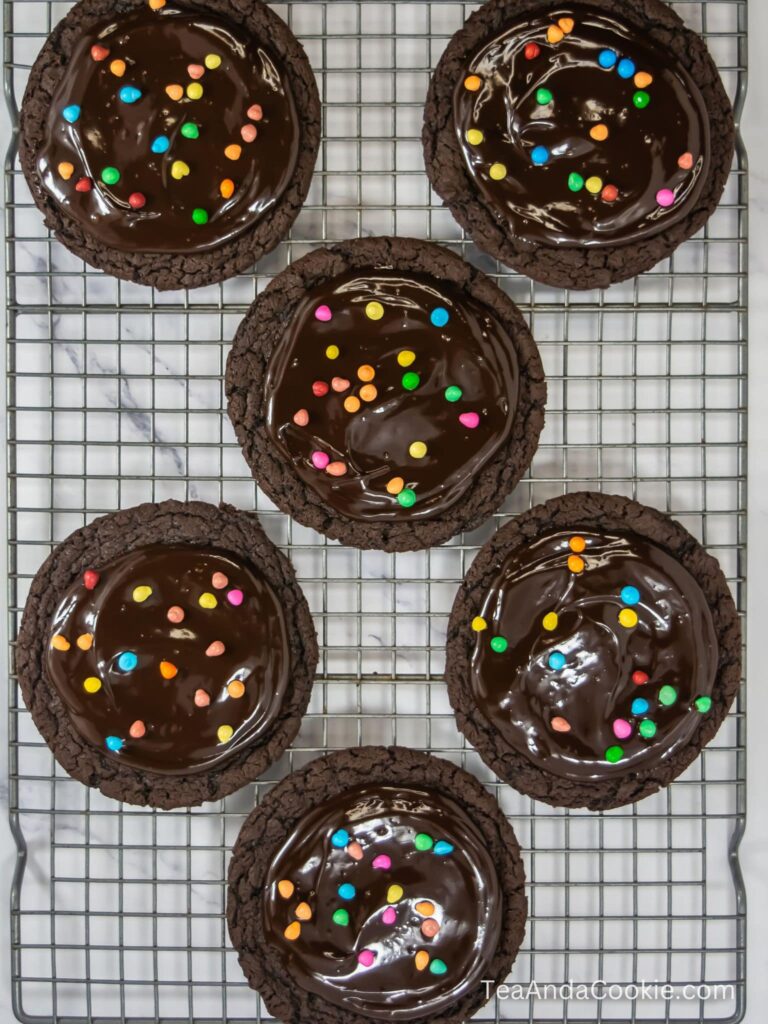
[4,0,746,1024]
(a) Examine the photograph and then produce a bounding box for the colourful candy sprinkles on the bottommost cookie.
[278,828,454,975]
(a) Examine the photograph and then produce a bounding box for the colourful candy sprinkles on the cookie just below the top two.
[293,301,480,508]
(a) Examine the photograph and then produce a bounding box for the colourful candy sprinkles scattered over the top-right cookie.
[464,17,694,208]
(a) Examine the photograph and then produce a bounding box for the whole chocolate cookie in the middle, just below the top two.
[226,239,546,551]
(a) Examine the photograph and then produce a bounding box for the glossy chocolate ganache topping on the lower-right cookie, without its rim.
[471,532,718,781]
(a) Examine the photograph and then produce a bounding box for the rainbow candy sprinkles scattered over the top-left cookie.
[56,0,263,224]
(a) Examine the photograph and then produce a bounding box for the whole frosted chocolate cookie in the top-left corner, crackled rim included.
[19,0,319,289]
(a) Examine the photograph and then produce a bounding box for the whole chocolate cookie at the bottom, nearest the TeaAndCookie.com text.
[227,746,526,1024]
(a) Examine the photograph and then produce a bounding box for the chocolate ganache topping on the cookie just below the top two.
[266,269,519,520]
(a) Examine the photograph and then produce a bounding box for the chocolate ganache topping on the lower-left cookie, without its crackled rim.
[46,545,289,775]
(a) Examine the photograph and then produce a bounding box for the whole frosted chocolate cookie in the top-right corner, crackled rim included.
[423,0,735,289]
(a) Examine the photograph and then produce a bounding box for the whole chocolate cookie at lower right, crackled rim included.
[447,493,741,810]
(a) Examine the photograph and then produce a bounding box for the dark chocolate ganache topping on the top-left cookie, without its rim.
[38,3,299,253]
